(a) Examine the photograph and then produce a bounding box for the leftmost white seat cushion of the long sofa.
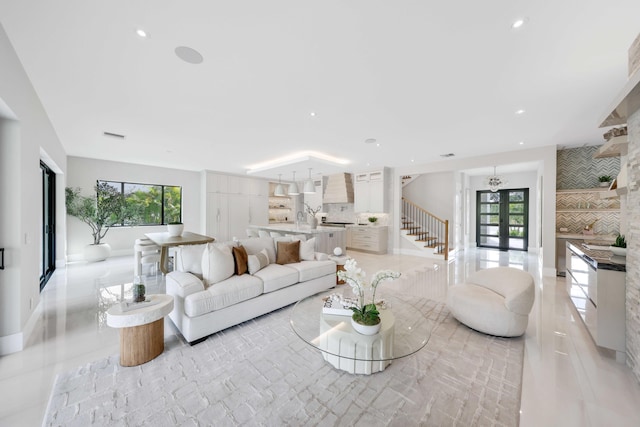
[184,274,263,317]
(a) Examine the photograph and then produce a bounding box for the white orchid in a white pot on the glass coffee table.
[337,258,400,335]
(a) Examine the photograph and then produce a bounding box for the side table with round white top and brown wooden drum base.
[107,294,173,366]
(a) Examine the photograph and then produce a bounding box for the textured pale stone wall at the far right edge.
[627,110,640,381]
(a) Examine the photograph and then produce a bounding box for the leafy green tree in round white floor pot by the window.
[65,182,134,262]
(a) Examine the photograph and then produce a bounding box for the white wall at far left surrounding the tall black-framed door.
[0,26,66,355]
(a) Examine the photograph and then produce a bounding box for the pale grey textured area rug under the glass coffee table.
[43,297,524,427]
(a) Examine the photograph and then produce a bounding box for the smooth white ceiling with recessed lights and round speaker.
[0,0,640,180]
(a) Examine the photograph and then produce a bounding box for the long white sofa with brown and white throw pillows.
[166,237,336,344]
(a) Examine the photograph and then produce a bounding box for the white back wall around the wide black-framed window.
[67,157,203,262]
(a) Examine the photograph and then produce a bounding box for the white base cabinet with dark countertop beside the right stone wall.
[565,243,626,361]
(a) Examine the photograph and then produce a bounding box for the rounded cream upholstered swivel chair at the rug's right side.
[447,267,535,337]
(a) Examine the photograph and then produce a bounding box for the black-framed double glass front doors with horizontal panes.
[476,188,529,251]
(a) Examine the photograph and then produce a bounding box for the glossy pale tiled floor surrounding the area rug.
[0,249,640,427]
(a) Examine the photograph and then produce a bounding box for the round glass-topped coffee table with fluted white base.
[290,289,433,374]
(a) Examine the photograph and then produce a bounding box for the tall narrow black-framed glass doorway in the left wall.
[39,161,56,291]
